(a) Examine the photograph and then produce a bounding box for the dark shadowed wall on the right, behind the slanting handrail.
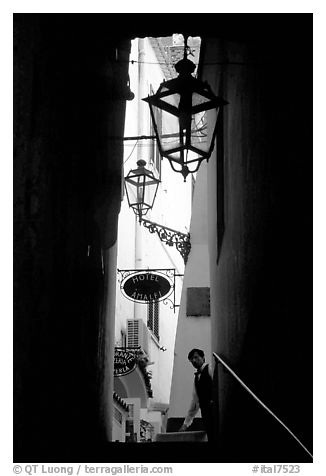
[204,25,312,461]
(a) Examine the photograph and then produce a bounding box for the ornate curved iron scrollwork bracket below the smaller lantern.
[141,219,191,264]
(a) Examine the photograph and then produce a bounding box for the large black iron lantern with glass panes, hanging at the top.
[143,36,228,181]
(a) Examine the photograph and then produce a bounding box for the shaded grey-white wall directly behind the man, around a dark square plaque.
[168,162,212,418]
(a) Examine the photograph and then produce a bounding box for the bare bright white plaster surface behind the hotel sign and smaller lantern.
[115,39,191,419]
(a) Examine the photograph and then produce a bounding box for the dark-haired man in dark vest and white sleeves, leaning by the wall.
[179,349,213,441]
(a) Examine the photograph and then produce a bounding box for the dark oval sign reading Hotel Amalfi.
[121,272,172,303]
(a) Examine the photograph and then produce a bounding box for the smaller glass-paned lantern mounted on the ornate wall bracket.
[125,160,160,223]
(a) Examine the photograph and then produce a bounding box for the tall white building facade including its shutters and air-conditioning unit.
[114,37,193,442]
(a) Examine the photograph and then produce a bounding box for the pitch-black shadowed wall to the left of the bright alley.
[14,14,130,459]
